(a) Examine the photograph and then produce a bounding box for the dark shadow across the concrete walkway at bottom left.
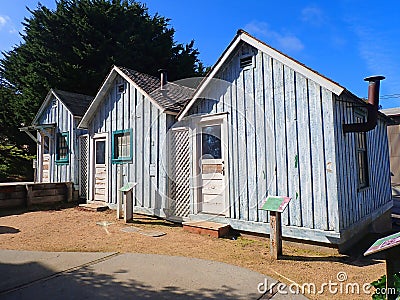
[0,263,255,300]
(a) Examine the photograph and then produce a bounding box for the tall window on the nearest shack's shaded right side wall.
[354,111,370,191]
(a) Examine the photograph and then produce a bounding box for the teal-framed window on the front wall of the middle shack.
[112,129,133,163]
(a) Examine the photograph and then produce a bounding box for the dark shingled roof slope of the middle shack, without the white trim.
[118,67,194,112]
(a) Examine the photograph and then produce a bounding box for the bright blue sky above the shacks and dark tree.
[0,0,400,108]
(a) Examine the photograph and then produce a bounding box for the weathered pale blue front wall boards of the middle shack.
[89,76,168,216]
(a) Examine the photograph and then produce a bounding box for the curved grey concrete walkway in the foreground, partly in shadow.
[0,250,306,300]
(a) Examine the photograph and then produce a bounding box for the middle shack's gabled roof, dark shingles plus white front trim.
[78,66,194,128]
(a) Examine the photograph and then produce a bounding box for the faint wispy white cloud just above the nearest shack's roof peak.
[244,21,304,52]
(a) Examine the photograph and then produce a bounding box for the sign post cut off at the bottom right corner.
[364,232,400,300]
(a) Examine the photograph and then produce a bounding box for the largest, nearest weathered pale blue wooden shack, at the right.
[173,31,392,246]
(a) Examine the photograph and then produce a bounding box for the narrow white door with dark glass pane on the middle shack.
[93,138,107,201]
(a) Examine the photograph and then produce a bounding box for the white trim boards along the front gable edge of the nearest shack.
[178,30,345,121]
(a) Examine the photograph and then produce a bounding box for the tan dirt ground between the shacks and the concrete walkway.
[0,207,385,299]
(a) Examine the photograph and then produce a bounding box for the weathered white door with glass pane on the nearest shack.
[199,119,227,215]
